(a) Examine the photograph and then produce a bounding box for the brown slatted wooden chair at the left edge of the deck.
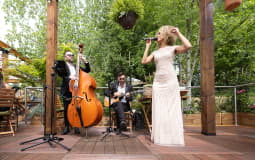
[0,88,17,136]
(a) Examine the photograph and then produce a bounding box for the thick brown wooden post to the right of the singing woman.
[200,0,216,135]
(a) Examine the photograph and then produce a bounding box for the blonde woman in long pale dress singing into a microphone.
[142,26,191,146]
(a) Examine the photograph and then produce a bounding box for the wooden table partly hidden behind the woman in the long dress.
[139,89,188,134]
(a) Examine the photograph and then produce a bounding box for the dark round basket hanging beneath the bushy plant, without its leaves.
[118,11,138,29]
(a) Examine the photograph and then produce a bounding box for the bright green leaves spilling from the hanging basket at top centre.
[109,0,144,22]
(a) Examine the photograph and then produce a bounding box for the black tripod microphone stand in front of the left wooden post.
[20,63,71,151]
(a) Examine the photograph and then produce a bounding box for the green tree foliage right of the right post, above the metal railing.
[214,0,255,85]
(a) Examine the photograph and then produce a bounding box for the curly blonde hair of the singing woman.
[158,25,177,46]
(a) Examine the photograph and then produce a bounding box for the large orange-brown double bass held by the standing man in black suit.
[67,44,103,128]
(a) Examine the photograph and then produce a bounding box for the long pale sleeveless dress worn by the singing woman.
[151,46,184,146]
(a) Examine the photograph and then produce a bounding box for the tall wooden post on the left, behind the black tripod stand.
[45,0,58,135]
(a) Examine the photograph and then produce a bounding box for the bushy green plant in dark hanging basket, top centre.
[110,0,144,29]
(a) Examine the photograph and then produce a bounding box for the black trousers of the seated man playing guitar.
[112,101,130,128]
